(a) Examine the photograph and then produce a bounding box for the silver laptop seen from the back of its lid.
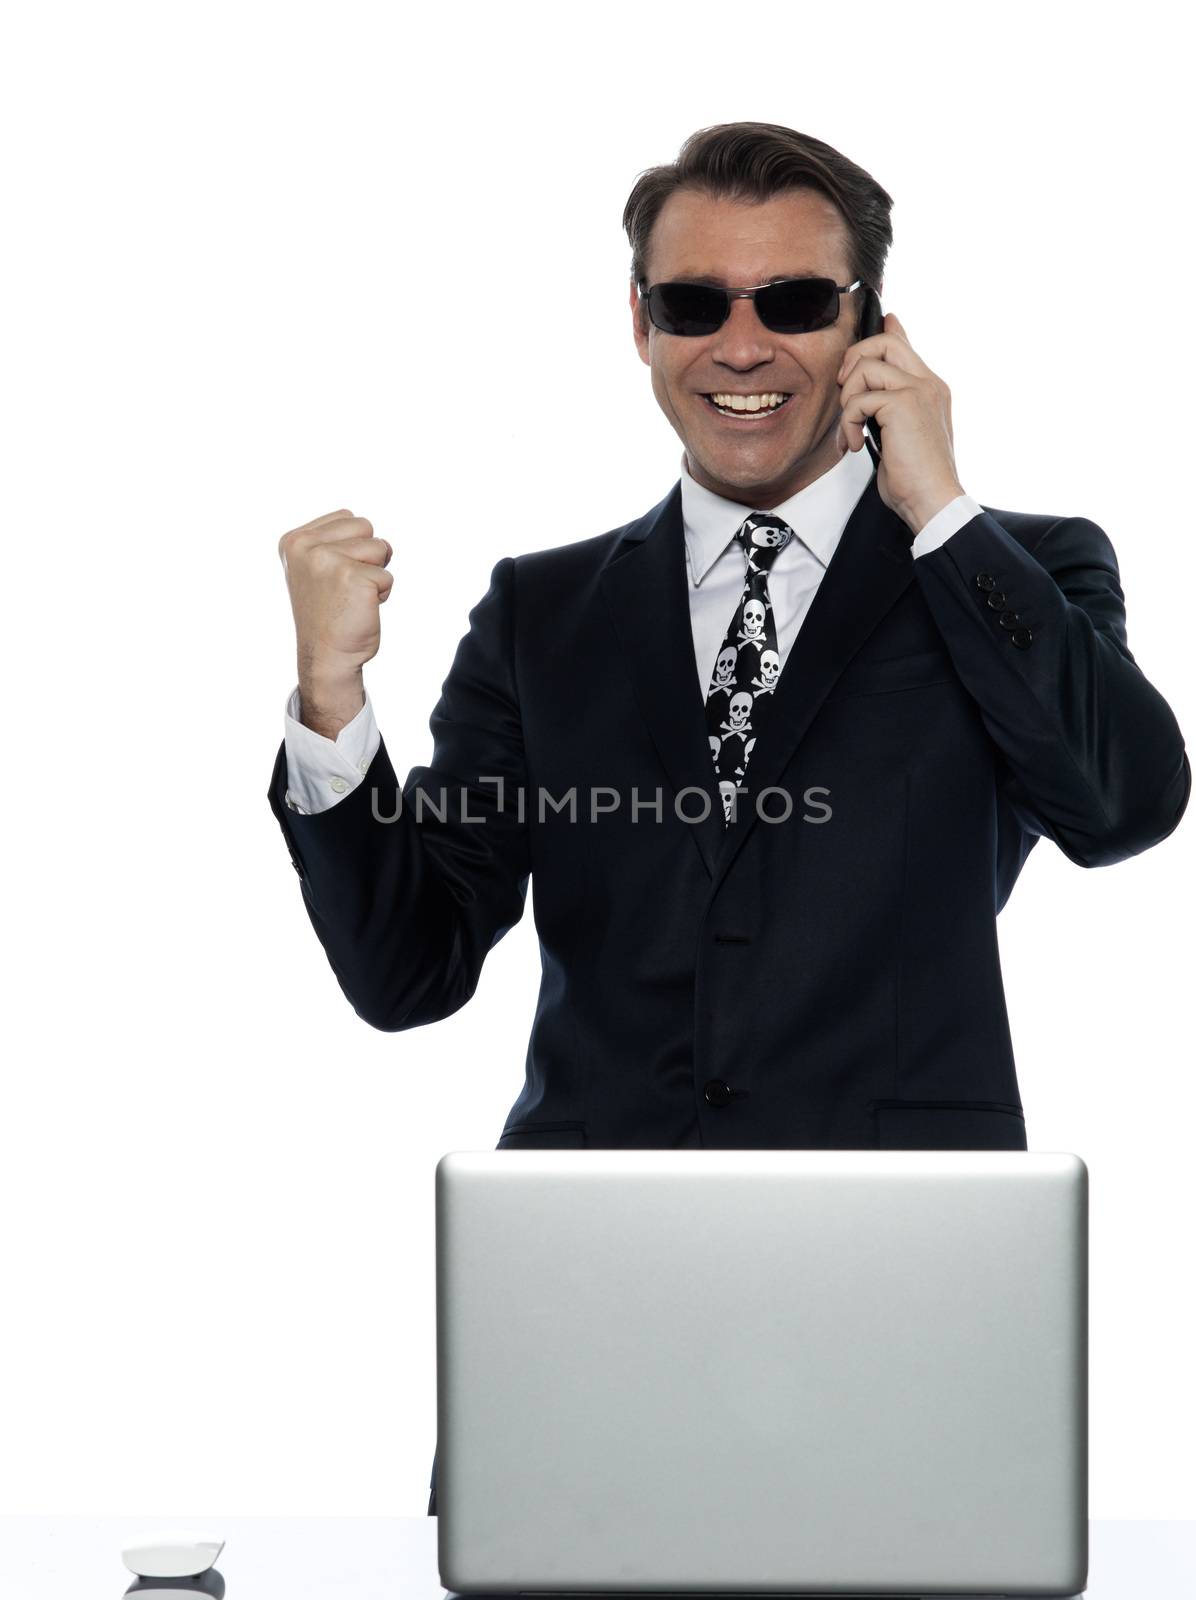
[437,1149,1087,1597]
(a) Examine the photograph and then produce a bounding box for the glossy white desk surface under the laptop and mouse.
[0,1515,1196,1600]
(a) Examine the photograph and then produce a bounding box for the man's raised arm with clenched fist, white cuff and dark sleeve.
[269,510,531,1032]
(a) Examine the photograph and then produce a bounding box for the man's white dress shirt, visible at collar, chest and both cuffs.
[285,446,982,816]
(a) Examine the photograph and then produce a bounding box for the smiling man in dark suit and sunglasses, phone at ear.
[270,123,1191,1510]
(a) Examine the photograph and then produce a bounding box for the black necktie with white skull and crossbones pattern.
[707,510,795,826]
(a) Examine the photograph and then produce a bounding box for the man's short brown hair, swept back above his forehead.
[624,122,892,331]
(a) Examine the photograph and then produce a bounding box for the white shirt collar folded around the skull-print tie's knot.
[681,445,875,584]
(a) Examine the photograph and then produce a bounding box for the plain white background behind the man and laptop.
[0,0,1196,1517]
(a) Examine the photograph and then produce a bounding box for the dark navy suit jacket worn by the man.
[269,444,1191,1149]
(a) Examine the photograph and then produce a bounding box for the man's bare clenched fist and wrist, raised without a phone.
[278,510,395,739]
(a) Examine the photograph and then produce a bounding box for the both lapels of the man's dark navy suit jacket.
[601,445,913,877]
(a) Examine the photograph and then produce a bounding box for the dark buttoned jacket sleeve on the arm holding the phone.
[915,510,1191,867]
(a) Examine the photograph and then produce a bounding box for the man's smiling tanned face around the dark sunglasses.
[630,189,860,510]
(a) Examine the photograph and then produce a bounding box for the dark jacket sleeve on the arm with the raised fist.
[269,557,531,1032]
